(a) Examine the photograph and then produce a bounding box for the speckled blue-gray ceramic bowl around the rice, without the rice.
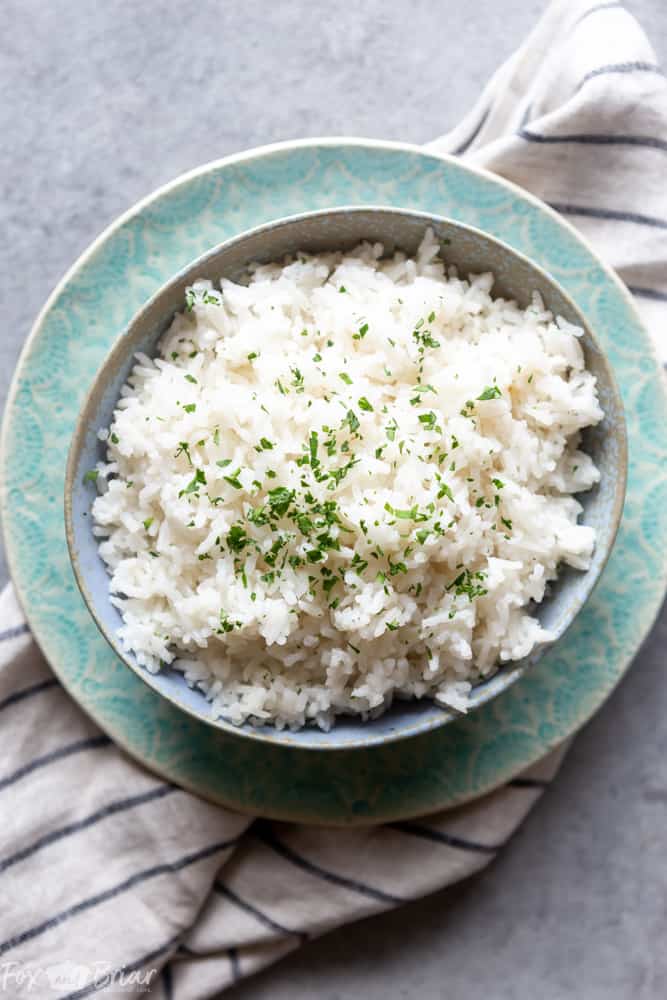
[65,207,627,749]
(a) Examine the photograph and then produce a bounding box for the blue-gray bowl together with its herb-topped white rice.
[65,208,627,749]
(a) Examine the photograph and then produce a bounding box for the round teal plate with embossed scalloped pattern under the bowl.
[0,139,667,824]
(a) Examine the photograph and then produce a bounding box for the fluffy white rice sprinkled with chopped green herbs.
[93,231,603,729]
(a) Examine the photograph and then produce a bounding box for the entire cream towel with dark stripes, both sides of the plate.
[0,0,667,1000]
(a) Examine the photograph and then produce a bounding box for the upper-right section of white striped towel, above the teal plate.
[429,0,667,363]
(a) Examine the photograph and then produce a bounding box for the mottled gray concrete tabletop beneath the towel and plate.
[0,0,667,1000]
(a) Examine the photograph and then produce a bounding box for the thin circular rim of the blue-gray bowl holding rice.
[63,204,628,752]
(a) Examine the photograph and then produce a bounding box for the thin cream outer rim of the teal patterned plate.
[0,135,667,826]
